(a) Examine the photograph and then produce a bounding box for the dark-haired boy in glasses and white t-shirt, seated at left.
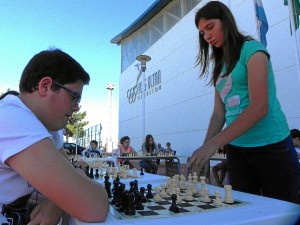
[0,49,108,224]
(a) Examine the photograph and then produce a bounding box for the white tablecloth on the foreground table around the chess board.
[70,173,300,225]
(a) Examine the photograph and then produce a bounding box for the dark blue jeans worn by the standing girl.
[227,136,299,203]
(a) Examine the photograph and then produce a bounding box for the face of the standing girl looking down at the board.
[198,19,224,48]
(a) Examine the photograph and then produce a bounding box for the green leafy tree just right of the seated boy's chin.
[66,111,89,138]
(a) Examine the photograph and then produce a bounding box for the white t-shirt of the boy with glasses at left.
[0,95,52,207]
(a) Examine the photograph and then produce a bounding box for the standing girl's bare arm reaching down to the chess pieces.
[189,51,268,170]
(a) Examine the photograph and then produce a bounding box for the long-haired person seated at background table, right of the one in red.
[140,134,158,174]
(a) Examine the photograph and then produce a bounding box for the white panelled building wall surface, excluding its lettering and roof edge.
[119,0,300,156]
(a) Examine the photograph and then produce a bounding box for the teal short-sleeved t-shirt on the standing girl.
[216,40,290,147]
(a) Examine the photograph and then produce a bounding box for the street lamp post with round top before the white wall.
[136,55,151,140]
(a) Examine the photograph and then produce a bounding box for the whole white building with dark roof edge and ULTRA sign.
[112,0,300,156]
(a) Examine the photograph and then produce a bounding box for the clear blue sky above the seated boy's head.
[0,0,155,125]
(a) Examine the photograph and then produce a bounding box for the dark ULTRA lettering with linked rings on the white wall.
[127,70,161,104]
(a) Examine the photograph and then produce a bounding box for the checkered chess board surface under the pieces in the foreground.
[109,190,248,220]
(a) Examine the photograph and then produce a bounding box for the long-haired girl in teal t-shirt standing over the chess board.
[188,1,299,202]
